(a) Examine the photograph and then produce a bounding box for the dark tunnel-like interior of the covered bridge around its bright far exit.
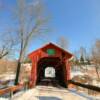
[36,57,67,87]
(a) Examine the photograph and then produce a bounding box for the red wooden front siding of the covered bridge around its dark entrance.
[29,43,73,87]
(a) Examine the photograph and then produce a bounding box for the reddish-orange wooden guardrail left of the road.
[0,85,23,96]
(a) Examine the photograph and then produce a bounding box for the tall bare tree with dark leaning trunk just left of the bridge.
[8,0,48,85]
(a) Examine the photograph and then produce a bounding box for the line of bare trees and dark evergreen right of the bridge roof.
[72,39,100,80]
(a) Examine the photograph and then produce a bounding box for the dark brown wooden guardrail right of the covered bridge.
[68,80,100,92]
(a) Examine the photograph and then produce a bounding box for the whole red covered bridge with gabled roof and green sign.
[28,43,73,87]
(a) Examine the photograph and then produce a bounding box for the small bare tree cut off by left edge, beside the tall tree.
[0,32,15,59]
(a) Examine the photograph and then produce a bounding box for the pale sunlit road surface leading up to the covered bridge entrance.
[12,86,87,100]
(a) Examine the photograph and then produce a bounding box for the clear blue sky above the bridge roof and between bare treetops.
[0,0,100,52]
